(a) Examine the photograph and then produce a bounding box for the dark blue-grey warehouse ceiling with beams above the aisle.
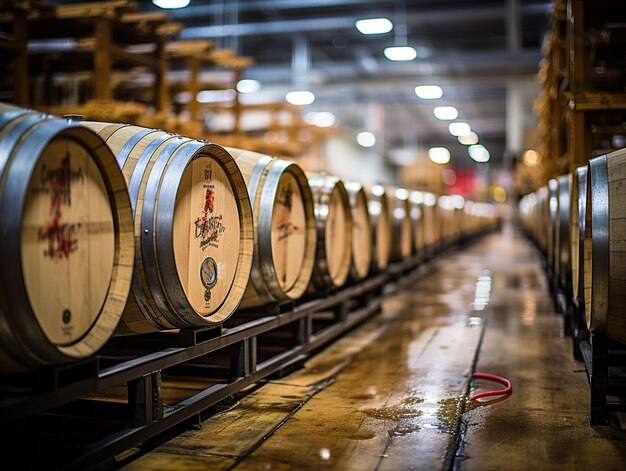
[56,0,551,170]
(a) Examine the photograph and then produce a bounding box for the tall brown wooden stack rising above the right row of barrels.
[535,0,626,187]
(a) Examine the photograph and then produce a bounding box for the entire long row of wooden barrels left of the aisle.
[0,104,497,373]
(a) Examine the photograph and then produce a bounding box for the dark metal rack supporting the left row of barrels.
[0,232,490,470]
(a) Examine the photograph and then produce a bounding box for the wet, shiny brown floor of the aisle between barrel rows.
[119,227,626,471]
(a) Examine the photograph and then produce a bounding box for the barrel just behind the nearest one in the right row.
[570,165,587,309]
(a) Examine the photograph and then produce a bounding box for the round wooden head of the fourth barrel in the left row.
[324,187,349,282]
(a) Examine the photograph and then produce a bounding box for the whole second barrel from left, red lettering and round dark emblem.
[83,122,254,335]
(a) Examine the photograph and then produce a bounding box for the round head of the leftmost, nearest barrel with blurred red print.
[21,138,115,345]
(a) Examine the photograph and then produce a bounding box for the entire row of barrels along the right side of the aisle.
[519,149,626,343]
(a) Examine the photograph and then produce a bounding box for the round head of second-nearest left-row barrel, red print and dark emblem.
[173,154,240,316]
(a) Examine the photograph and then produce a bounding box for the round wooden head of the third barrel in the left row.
[272,172,306,292]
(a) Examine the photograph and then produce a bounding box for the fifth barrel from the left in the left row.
[344,182,373,280]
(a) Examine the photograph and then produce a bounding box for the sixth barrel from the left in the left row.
[366,185,391,271]
